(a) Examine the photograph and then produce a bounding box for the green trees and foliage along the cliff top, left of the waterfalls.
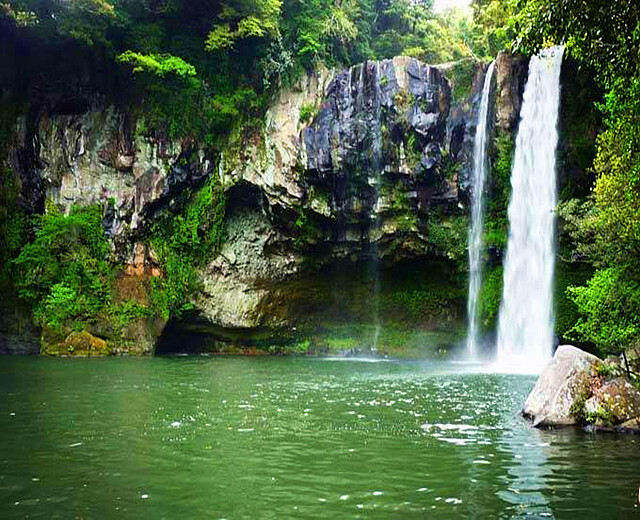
[0,0,495,145]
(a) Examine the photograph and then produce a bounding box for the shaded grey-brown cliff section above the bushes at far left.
[8,105,212,262]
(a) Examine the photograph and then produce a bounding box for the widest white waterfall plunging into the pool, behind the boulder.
[497,47,564,373]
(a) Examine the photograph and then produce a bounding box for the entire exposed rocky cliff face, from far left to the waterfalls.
[3,57,521,351]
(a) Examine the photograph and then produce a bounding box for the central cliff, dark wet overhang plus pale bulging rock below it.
[198,57,483,334]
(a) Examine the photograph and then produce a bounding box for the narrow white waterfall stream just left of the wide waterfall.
[467,62,495,358]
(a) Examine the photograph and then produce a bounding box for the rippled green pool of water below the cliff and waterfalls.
[0,358,640,519]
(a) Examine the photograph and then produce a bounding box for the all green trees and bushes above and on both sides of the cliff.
[0,0,640,360]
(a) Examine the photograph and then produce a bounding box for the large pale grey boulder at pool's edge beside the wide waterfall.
[522,345,600,427]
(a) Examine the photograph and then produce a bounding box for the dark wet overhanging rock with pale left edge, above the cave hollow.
[224,57,484,262]
